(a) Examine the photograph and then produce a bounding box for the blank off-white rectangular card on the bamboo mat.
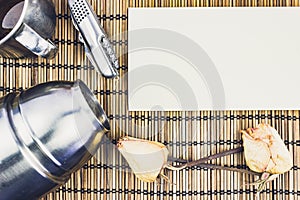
[128,7,300,111]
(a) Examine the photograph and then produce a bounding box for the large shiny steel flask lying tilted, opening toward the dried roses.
[0,80,110,200]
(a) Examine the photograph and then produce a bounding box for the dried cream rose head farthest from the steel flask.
[241,124,293,174]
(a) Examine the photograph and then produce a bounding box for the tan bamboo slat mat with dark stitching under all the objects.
[0,0,300,200]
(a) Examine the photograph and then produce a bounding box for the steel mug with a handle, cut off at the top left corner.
[0,0,57,58]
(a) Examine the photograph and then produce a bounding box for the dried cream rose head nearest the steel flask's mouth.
[117,136,169,182]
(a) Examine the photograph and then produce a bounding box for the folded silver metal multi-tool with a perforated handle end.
[68,0,119,78]
